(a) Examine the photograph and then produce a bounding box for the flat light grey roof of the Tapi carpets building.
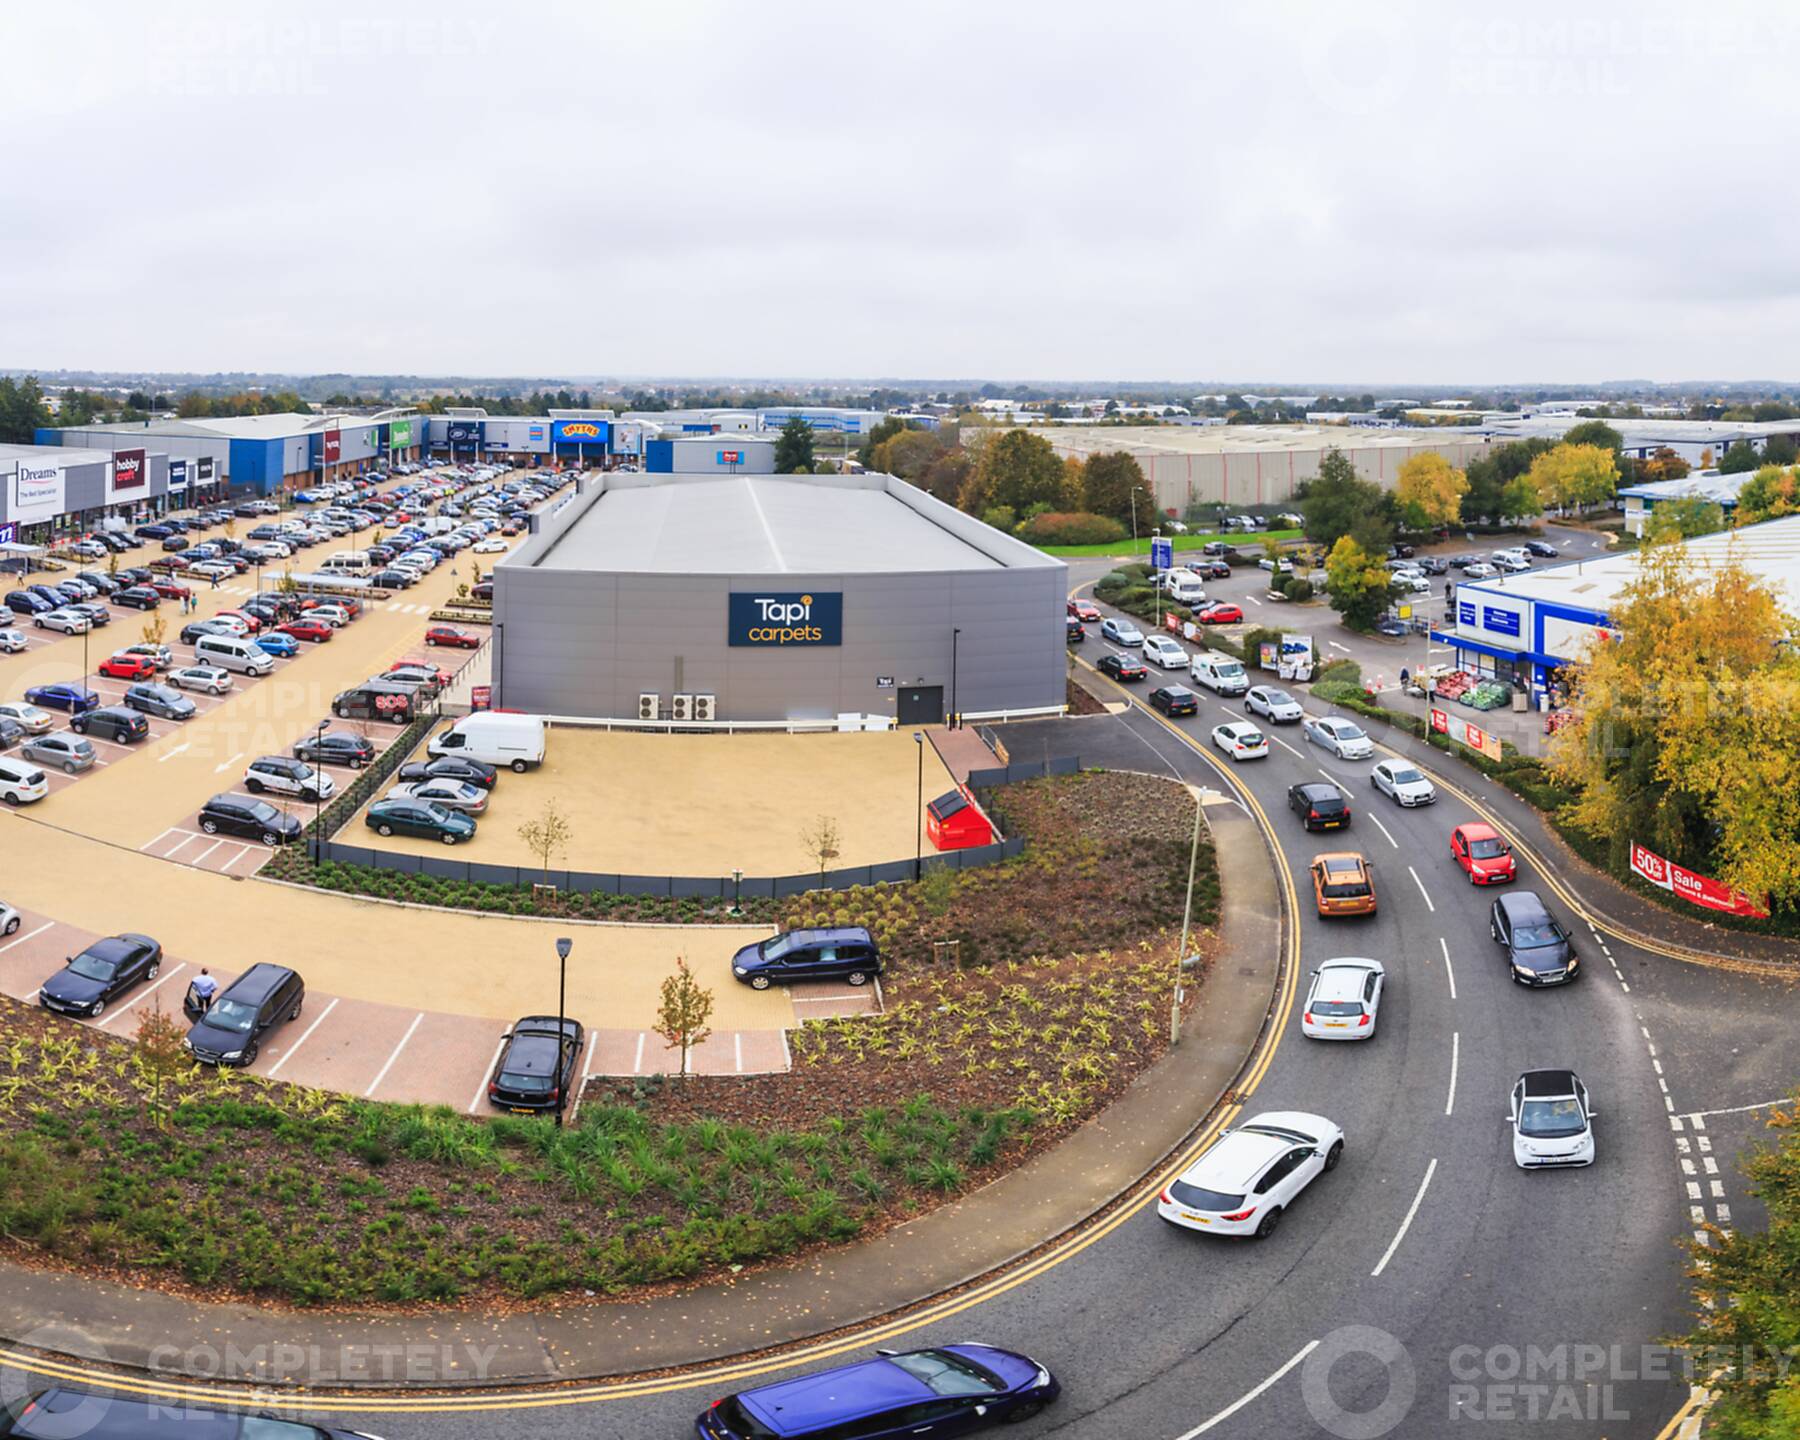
[535,471,1015,574]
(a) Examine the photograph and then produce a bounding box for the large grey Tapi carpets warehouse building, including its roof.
[493,472,1067,729]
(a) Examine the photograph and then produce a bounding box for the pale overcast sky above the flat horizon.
[0,0,1800,385]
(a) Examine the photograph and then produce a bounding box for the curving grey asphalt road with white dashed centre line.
[3,532,1756,1440]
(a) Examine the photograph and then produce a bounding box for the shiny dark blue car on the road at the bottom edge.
[695,1345,1062,1440]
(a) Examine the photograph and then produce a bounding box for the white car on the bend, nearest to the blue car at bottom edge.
[1156,1111,1345,1240]
